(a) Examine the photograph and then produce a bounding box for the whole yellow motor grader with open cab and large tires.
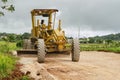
[18,9,80,63]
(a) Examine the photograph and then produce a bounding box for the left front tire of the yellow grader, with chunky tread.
[37,39,46,63]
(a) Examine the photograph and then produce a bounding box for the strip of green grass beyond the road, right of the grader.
[80,43,120,53]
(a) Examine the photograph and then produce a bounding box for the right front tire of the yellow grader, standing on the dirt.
[72,39,80,62]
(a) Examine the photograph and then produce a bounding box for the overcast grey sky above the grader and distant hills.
[0,0,120,37]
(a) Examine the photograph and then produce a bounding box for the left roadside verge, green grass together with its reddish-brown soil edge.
[0,41,33,80]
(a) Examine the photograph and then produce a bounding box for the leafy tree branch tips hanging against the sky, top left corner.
[0,0,15,16]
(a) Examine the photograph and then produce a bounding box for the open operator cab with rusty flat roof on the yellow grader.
[31,9,58,30]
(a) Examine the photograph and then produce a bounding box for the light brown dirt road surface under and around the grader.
[20,51,120,80]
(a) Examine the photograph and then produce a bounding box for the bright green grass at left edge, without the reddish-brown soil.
[0,41,17,80]
